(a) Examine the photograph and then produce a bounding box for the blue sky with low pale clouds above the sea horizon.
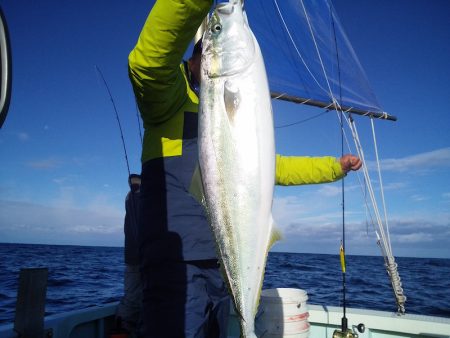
[0,0,450,258]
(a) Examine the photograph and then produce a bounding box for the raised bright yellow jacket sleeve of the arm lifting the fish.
[128,0,212,124]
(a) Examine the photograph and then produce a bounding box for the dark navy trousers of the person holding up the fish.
[142,261,230,338]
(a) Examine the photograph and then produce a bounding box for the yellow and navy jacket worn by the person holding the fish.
[129,0,343,260]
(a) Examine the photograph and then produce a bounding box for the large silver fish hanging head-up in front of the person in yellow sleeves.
[199,1,278,337]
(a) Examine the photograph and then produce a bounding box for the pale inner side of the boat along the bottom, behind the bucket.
[0,303,450,338]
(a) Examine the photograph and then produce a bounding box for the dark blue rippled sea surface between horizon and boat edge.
[0,243,450,324]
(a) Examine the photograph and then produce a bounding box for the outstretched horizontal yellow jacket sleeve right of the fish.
[275,154,344,185]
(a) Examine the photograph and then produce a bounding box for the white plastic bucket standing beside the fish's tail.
[255,288,309,338]
